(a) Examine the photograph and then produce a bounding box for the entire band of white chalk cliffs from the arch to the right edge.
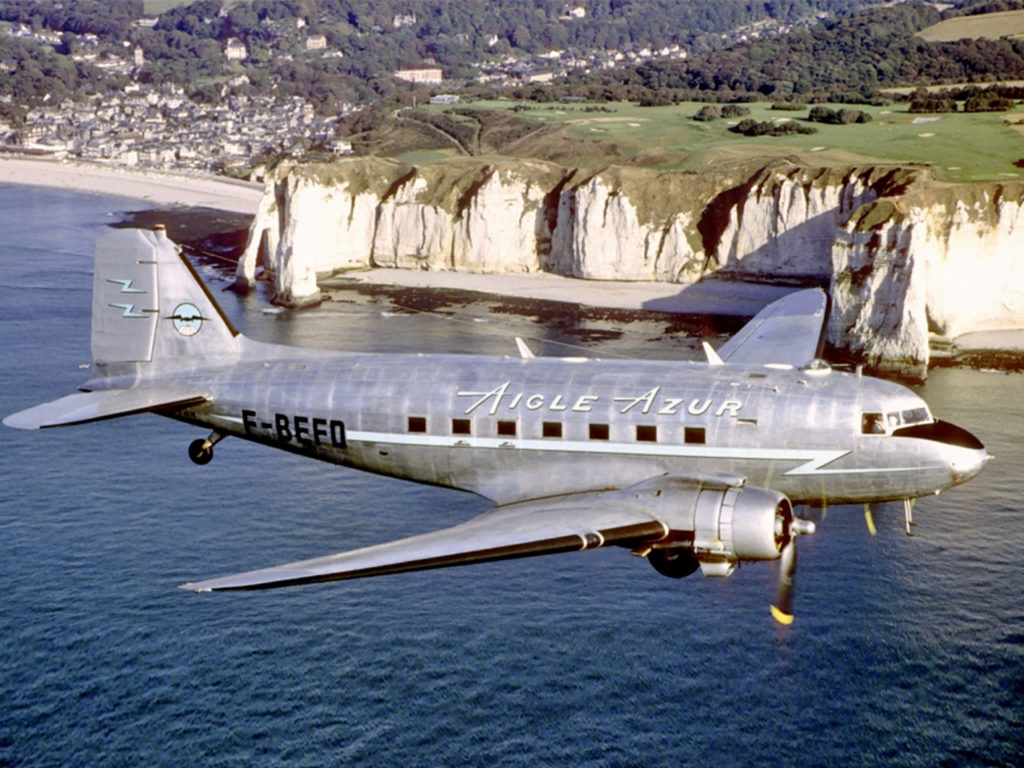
[239,159,1024,373]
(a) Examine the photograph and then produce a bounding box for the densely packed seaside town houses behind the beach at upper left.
[0,16,354,173]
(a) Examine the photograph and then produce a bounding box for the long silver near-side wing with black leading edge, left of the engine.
[181,492,669,592]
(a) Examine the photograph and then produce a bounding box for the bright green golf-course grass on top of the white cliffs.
[430,101,1024,181]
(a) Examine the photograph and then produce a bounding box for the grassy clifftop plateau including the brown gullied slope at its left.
[342,100,1024,181]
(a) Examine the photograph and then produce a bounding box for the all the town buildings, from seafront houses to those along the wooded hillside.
[0,16,686,178]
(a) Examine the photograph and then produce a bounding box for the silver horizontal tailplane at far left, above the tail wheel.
[3,387,206,429]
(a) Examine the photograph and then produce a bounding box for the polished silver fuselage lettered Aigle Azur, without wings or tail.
[165,340,984,504]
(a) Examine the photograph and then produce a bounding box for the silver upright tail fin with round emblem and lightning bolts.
[92,227,239,376]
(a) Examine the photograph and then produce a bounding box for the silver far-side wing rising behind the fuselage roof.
[718,288,828,368]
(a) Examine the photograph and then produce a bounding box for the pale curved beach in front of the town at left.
[0,155,263,214]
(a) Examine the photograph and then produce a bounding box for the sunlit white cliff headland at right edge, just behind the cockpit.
[828,182,1024,372]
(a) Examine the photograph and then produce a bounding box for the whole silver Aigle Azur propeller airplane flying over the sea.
[4,227,988,624]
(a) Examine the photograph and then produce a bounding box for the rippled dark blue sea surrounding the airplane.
[0,186,1024,766]
